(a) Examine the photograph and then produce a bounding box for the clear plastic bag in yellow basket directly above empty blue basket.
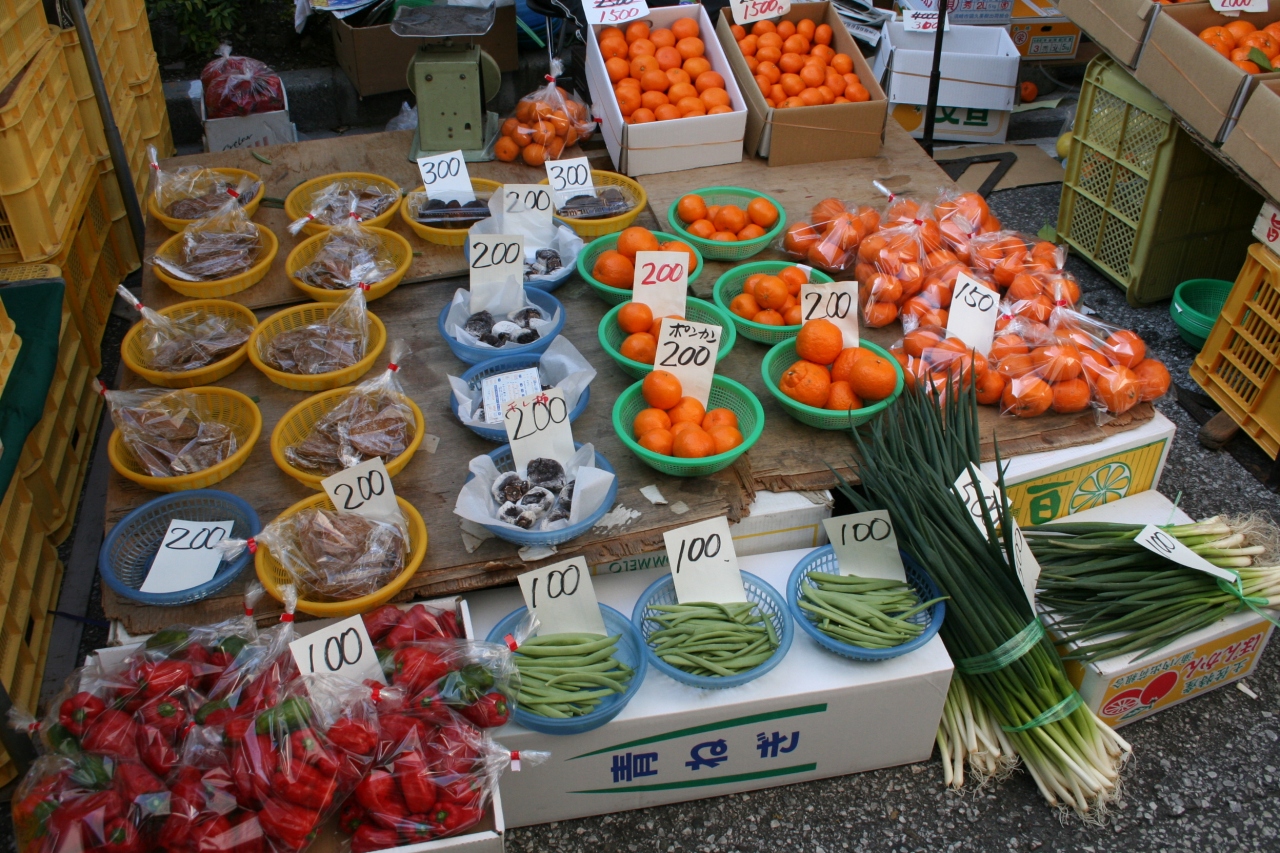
[102,388,239,476]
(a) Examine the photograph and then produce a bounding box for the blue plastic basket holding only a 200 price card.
[97,489,262,607]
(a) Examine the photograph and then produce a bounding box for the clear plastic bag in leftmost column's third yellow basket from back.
[116,284,253,373]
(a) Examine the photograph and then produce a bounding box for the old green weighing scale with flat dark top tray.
[392,0,502,161]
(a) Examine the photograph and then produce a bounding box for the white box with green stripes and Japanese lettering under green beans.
[467,549,952,826]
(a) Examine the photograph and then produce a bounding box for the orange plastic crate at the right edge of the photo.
[1192,243,1280,459]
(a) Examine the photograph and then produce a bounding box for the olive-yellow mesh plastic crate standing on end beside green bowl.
[1057,56,1262,305]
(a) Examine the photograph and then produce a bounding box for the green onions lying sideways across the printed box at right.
[1025,517,1280,661]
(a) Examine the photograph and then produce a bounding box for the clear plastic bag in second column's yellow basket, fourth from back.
[284,339,415,476]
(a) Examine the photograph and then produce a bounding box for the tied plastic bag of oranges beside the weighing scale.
[493,59,595,167]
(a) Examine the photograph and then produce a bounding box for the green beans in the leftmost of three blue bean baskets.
[515,634,634,720]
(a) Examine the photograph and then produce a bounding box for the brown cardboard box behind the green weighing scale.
[332,5,520,97]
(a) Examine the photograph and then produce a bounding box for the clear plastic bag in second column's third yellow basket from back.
[259,284,369,375]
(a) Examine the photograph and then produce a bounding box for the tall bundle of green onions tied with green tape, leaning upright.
[841,387,1130,813]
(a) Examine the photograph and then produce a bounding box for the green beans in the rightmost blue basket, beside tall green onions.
[800,571,943,648]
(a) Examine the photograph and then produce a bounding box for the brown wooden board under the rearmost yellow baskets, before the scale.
[142,131,608,310]
